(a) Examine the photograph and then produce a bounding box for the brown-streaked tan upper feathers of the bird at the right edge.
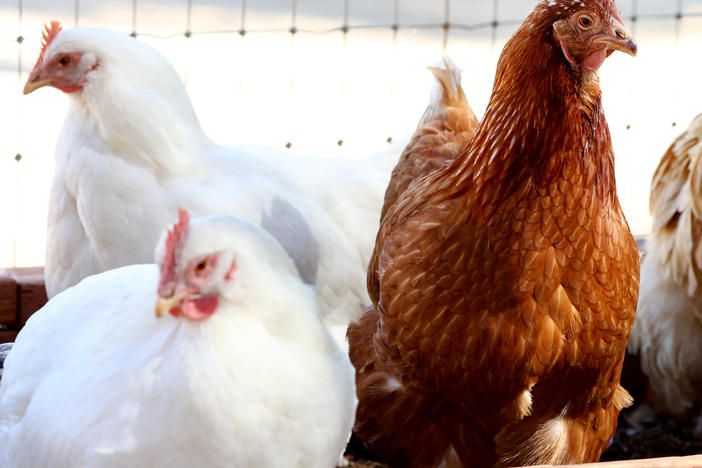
[650,114,702,295]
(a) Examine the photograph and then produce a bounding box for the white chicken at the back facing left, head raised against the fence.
[24,21,401,344]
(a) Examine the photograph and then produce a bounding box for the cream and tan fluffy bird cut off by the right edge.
[629,115,702,414]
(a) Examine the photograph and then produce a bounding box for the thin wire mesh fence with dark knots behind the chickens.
[0,0,702,263]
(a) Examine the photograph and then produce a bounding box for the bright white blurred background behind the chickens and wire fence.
[0,0,702,268]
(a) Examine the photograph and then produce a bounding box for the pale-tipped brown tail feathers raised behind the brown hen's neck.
[380,57,478,221]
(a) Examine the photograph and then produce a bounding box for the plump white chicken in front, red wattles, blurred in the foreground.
[0,212,356,468]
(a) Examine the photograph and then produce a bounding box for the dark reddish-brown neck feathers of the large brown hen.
[449,12,616,210]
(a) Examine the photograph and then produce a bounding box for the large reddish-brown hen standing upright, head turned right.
[348,0,639,468]
